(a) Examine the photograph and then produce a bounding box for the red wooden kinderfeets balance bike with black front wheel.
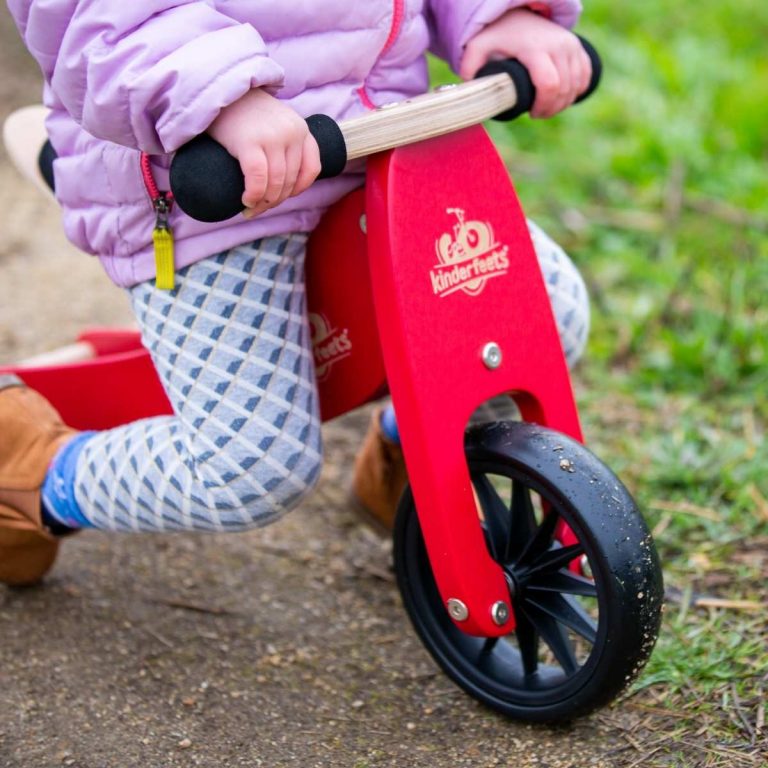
[0,42,662,721]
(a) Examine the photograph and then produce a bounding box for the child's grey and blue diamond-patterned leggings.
[75,227,589,531]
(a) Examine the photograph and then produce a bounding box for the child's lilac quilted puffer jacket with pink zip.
[8,0,580,286]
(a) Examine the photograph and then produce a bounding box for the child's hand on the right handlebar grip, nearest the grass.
[459,8,592,117]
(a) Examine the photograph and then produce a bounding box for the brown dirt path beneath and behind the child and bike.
[0,12,651,768]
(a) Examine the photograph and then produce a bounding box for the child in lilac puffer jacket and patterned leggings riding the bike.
[0,0,590,584]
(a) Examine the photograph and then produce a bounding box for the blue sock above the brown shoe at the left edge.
[41,432,96,534]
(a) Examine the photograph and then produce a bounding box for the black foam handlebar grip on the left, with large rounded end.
[170,115,347,222]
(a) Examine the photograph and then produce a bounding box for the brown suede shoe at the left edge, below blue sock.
[0,375,77,586]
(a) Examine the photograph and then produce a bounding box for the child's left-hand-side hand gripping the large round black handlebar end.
[208,88,320,219]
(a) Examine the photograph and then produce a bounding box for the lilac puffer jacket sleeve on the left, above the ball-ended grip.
[8,0,283,154]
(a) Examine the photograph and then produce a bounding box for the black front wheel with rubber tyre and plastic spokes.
[394,422,663,722]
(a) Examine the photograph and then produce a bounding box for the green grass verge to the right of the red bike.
[435,0,768,766]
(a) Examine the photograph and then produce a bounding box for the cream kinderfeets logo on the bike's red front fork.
[429,208,509,297]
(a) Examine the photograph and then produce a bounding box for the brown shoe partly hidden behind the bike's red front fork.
[352,408,408,535]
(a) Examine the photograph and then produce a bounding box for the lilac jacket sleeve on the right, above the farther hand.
[427,0,581,71]
